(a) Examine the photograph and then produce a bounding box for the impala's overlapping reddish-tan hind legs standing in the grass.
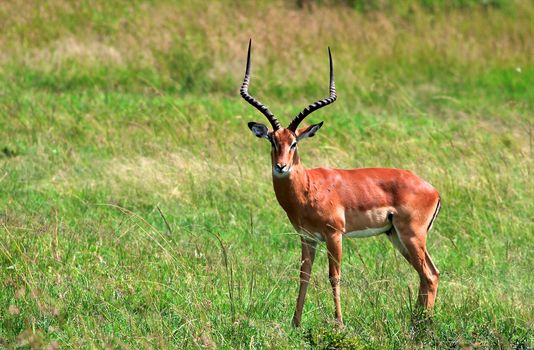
[388,218,439,310]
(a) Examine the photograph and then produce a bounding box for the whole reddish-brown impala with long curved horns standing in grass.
[240,42,440,326]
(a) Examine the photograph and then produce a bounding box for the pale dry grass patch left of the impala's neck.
[47,150,254,205]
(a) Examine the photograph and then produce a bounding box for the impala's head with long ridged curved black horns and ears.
[244,40,337,177]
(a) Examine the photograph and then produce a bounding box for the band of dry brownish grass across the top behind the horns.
[0,0,534,72]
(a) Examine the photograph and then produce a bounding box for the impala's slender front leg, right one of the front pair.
[325,231,343,326]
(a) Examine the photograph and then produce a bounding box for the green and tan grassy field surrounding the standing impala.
[0,0,534,349]
